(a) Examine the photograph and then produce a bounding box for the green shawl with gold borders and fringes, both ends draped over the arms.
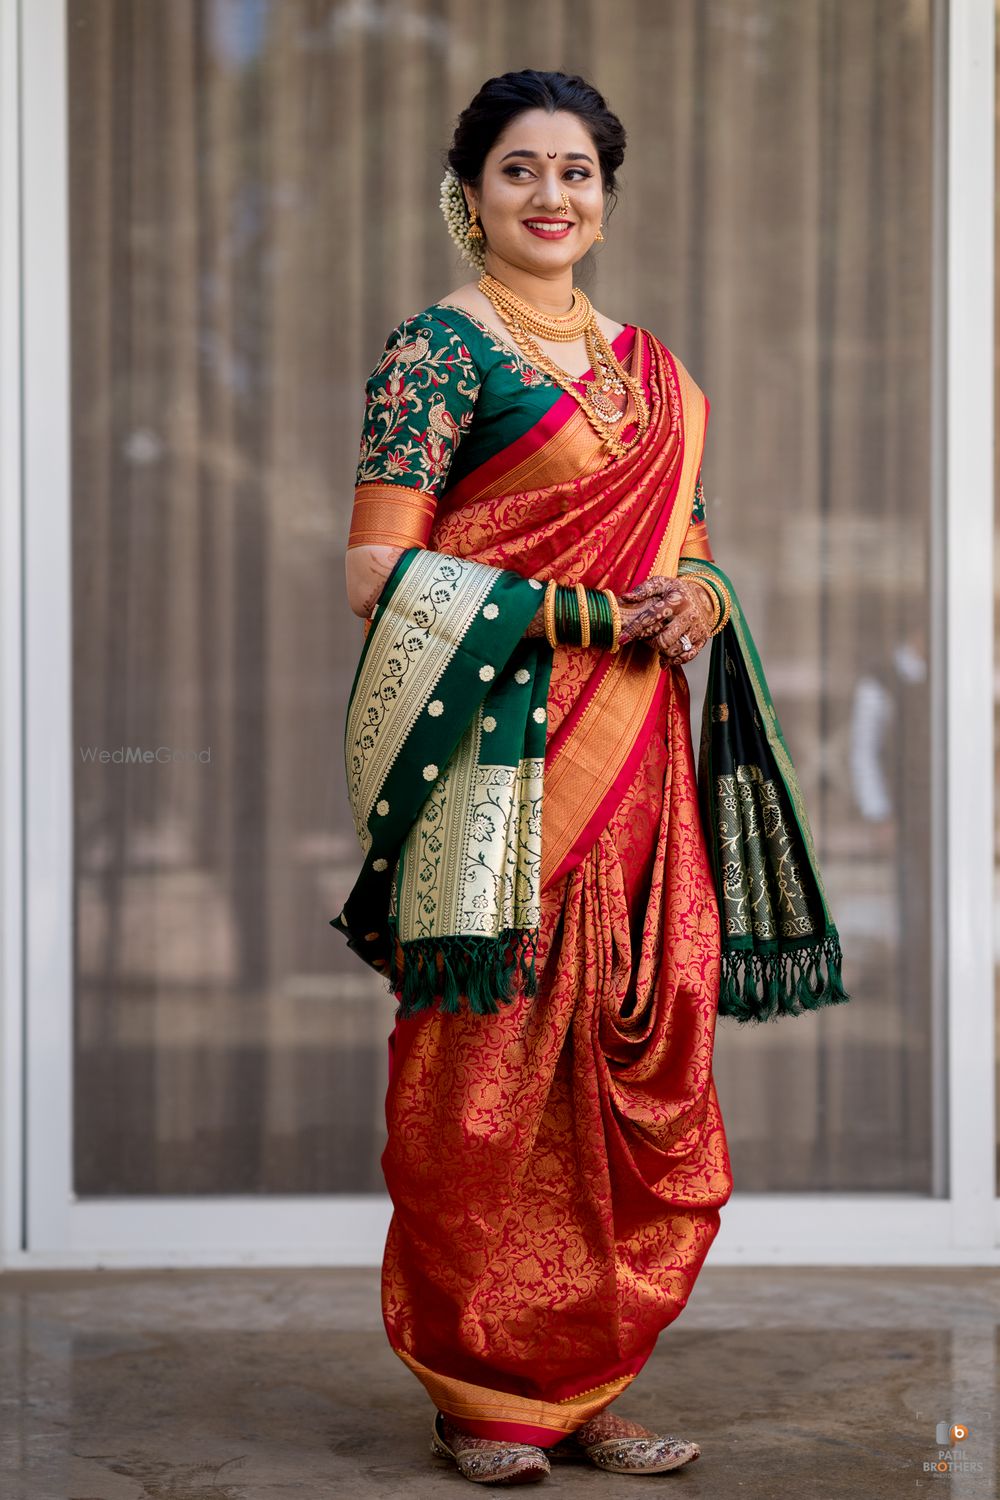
[330,548,849,1022]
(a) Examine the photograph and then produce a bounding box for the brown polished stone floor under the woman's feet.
[0,1266,1000,1500]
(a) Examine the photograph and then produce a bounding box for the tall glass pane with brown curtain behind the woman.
[67,0,943,1196]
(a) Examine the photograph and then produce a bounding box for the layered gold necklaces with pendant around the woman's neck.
[478,272,649,458]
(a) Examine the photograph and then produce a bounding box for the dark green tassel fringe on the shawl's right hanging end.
[718,935,850,1022]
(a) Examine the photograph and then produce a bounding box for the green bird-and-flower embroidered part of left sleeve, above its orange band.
[354,311,480,494]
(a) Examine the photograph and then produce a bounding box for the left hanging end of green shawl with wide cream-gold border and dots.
[330,548,552,1016]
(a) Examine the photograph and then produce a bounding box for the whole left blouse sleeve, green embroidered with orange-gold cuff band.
[348,311,480,548]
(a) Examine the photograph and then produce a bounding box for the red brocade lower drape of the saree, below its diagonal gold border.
[382,672,732,1445]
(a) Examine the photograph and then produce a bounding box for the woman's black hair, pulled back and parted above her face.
[445,68,625,229]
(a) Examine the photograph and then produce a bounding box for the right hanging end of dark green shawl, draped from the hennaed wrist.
[678,558,850,1022]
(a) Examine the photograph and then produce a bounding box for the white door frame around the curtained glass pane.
[0,0,1000,1266]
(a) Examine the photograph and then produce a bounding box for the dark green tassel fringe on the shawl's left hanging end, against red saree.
[393,927,538,1019]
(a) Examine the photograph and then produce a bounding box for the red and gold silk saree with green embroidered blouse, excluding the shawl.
[344,305,732,1446]
